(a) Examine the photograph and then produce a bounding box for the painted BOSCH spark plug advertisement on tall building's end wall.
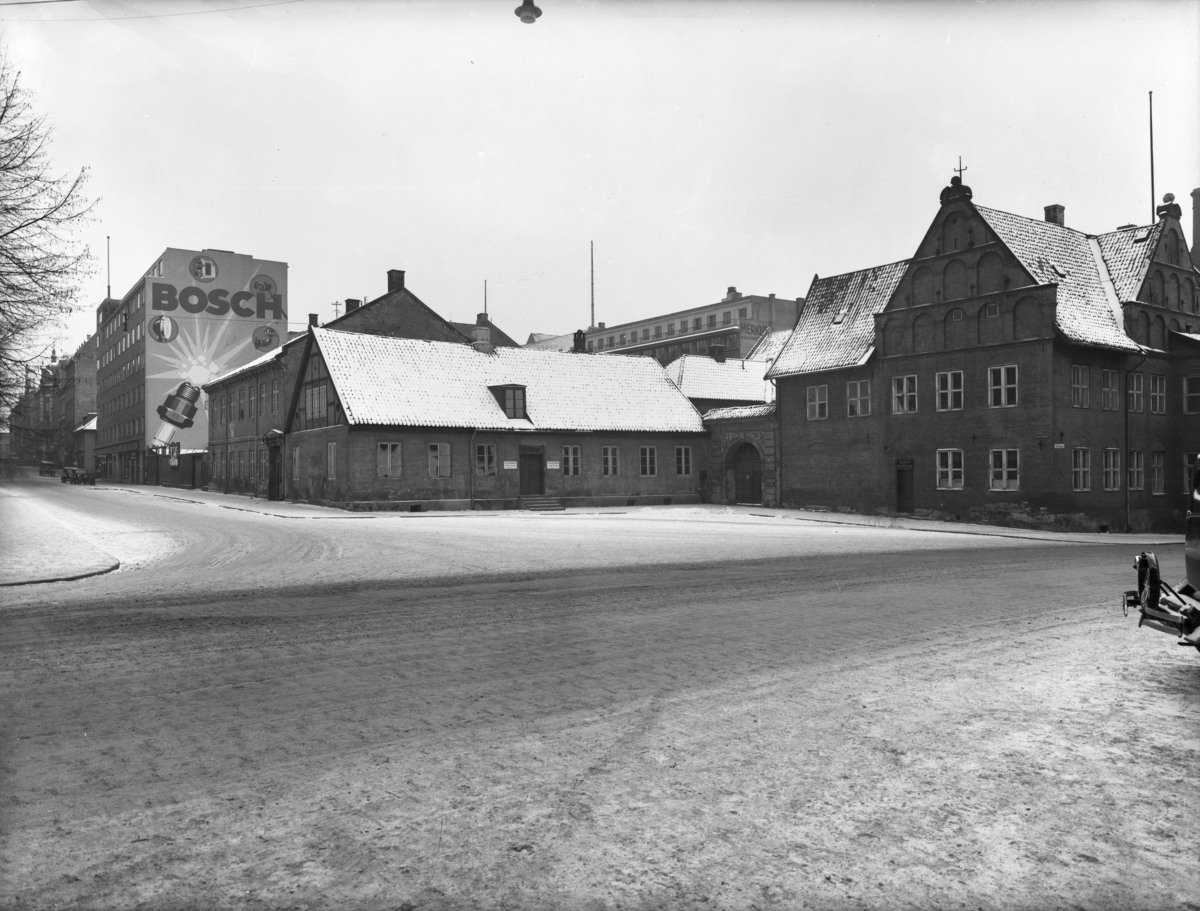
[145,250,288,451]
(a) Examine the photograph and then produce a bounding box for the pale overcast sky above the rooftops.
[0,0,1200,350]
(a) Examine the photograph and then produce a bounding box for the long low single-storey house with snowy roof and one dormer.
[284,317,706,511]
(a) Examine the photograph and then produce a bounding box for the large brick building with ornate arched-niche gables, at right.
[767,178,1200,531]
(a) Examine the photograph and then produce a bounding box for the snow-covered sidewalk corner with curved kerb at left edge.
[0,485,121,586]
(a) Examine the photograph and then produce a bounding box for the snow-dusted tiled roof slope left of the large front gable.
[767,259,908,378]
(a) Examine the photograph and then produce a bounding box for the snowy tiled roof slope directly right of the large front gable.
[976,205,1140,352]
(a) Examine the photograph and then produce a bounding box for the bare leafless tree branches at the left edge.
[0,48,92,426]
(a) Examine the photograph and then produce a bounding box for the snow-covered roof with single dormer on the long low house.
[312,329,704,433]
